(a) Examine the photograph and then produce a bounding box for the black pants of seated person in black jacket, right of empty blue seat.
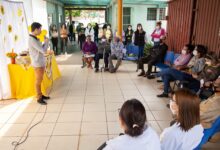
[137,55,158,75]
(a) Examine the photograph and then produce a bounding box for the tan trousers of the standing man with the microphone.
[34,67,44,99]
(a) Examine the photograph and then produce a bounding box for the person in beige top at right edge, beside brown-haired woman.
[200,77,220,142]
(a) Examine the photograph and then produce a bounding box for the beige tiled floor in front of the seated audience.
[0,51,219,150]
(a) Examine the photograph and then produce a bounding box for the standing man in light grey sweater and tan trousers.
[28,22,50,105]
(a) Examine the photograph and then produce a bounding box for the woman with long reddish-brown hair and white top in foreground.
[161,89,203,150]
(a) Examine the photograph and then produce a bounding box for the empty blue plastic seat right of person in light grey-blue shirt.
[124,45,139,61]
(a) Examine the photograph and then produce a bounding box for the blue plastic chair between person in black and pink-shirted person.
[155,51,175,70]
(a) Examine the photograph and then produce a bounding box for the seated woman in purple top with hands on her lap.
[82,35,97,69]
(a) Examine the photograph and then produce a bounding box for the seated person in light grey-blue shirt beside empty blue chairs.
[109,37,124,73]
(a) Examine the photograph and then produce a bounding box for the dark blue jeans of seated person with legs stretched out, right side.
[161,68,200,94]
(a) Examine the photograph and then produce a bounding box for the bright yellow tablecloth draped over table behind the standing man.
[8,56,61,99]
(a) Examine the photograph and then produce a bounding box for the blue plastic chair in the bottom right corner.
[194,116,220,150]
